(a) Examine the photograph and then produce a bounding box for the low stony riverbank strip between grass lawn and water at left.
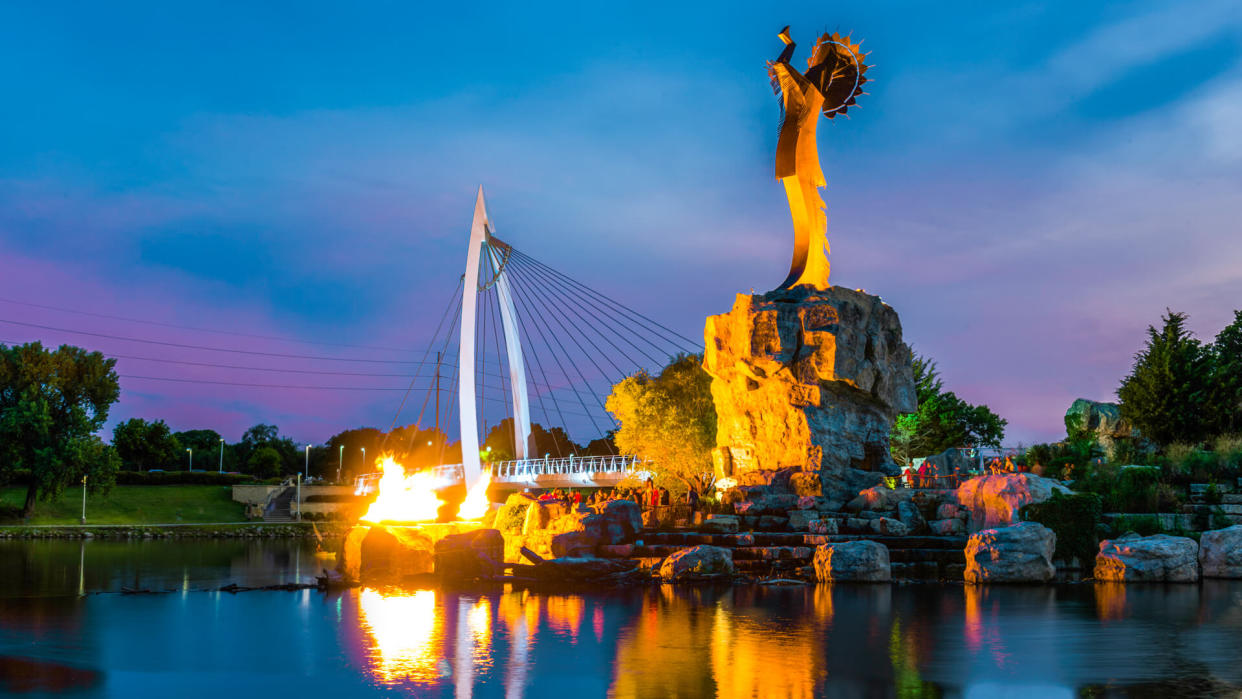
[0,521,349,539]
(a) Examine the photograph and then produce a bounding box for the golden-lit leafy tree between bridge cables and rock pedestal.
[606,354,715,487]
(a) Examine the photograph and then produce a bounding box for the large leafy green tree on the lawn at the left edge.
[0,343,120,518]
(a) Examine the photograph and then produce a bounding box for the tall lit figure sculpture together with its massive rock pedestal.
[703,27,917,504]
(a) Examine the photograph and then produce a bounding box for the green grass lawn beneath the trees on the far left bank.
[0,485,246,524]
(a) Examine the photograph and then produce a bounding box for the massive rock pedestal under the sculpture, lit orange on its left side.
[703,287,917,497]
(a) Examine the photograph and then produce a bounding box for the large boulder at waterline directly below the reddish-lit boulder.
[954,520,1057,584]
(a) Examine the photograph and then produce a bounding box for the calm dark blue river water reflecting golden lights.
[0,540,1242,699]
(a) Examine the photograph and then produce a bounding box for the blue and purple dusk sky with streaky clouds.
[0,1,1242,443]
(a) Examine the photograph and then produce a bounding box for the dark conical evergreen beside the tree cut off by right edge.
[1117,309,1212,444]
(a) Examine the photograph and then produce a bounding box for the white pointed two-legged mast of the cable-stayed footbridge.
[457,186,530,488]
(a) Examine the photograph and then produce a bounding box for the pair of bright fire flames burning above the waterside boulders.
[363,456,492,523]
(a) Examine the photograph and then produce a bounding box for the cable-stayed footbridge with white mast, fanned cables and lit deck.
[359,187,702,492]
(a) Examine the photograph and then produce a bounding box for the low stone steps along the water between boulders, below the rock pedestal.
[599,530,966,581]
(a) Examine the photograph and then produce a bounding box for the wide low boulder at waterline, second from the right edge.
[1095,534,1199,582]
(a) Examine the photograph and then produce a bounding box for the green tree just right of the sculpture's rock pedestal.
[891,355,1009,464]
